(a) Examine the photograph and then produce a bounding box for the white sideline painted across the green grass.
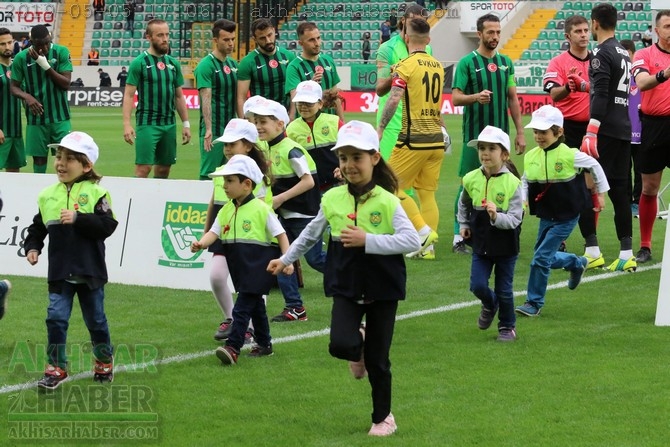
[0,262,661,394]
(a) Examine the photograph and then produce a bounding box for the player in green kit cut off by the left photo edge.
[0,28,26,172]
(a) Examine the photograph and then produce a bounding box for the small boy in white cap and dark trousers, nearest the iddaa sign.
[191,155,293,365]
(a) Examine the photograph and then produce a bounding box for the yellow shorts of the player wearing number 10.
[389,147,444,191]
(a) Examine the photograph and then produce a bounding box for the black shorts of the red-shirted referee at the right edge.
[635,115,670,174]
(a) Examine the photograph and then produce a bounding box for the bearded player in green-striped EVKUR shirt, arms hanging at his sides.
[123,19,191,178]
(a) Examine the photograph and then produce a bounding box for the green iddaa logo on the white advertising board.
[158,202,207,268]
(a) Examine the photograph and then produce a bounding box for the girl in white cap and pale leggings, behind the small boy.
[205,118,272,342]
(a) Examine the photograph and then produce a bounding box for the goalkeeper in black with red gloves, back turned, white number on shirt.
[572,3,637,271]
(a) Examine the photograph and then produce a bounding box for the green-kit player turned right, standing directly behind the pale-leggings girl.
[193,19,237,180]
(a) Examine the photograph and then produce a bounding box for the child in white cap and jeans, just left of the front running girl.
[249,100,326,322]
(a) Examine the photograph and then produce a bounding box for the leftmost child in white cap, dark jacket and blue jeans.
[24,132,118,389]
